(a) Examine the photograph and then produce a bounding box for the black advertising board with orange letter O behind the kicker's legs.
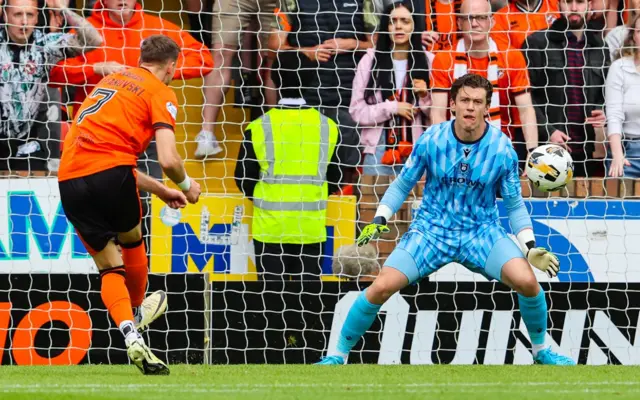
[0,274,209,365]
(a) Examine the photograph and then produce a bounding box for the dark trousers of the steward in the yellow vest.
[253,239,322,281]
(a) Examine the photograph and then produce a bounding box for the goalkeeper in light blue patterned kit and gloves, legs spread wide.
[319,74,575,365]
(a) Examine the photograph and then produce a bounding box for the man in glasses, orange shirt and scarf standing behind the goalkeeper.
[431,0,538,165]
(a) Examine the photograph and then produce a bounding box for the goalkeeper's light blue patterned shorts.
[385,224,524,284]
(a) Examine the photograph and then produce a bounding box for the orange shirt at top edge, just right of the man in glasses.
[491,0,560,50]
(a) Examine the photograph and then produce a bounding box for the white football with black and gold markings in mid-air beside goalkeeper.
[525,144,573,192]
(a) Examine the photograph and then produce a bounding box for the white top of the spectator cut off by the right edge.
[606,57,640,139]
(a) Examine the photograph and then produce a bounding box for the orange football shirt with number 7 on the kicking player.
[58,68,178,181]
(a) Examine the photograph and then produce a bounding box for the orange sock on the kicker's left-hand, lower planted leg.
[100,266,133,328]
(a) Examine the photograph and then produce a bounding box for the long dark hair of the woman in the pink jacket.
[364,0,429,104]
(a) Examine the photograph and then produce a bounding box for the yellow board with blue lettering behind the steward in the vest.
[151,195,356,280]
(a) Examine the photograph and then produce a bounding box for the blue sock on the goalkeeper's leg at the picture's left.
[337,289,382,359]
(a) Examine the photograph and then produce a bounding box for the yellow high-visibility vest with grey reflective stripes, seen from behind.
[248,108,338,244]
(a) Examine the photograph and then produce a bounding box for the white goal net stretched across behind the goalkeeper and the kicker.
[0,0,640,365]
